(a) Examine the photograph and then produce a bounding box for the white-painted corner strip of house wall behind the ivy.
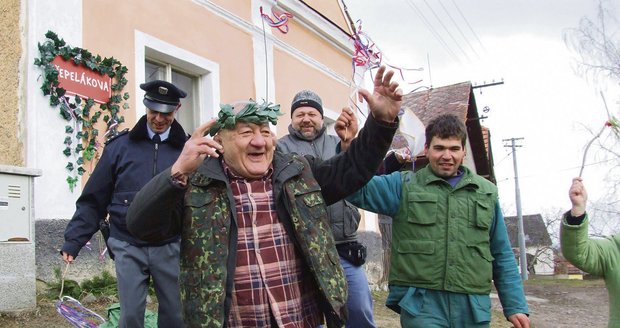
[23,0,82,219]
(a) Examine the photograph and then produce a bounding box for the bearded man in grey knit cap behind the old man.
[277,90,375,328]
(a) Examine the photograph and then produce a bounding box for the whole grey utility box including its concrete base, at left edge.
[0,165,41,312]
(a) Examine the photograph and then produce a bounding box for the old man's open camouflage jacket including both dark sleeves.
[127,118,396,327]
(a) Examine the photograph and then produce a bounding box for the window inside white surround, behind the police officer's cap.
[144,59,200,133]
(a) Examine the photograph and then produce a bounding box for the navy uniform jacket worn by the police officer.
[62,115,187,257]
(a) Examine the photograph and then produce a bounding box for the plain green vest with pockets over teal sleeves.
[389,166,497,294]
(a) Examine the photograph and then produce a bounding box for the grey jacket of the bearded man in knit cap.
[277,125,360,244]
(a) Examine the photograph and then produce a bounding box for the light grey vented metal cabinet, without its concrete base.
[0,167,41,242]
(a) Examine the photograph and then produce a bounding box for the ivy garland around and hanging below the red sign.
[34,31,129,192]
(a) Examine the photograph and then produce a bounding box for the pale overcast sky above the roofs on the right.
[345,0,620,219]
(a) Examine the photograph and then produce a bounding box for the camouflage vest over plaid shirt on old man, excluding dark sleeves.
[179,155,347,328]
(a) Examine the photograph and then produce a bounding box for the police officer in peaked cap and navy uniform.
[61,80,187,327]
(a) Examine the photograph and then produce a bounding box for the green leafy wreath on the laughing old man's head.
[209,99,282,136]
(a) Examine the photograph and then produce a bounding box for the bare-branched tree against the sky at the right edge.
[564,0,620,236]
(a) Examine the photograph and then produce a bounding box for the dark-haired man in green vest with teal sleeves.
[347,114,530,328]
